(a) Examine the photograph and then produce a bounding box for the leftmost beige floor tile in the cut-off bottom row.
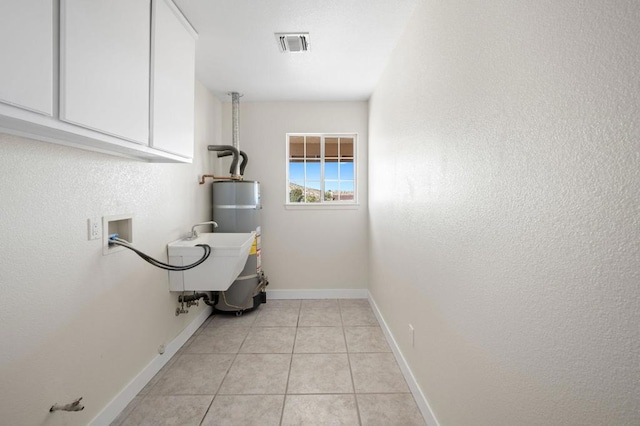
[122,395,213,426]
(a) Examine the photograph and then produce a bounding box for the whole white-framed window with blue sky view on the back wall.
[287,133,357,205]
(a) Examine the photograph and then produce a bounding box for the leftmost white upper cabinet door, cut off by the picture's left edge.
[0,0,53,115]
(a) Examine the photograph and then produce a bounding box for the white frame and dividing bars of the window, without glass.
[285,132,359,209]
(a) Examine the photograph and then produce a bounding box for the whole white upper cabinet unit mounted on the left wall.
[0,0,197,163]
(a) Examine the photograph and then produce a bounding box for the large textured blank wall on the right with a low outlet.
[369,0,640,426]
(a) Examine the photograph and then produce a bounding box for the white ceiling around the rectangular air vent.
[174,0,419,101]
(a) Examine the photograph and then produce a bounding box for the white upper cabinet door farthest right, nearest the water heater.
[151,0,195,158]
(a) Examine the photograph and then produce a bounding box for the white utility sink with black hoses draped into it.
[167,232,256,291]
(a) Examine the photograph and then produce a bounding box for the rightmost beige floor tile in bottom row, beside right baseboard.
[356,393,426,426]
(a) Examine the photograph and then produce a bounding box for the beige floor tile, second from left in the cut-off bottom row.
[202,395,284,426]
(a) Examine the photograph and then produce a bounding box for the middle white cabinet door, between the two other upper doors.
[60,0,151,145]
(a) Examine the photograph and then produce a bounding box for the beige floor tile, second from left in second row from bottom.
[218,354,291,395]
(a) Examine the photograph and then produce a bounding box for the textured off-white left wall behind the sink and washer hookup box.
[0,80,221,425]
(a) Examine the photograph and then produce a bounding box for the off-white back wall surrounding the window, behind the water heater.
[220,99,368,290]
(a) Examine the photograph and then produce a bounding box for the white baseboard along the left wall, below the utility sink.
[90,306,213,426]
